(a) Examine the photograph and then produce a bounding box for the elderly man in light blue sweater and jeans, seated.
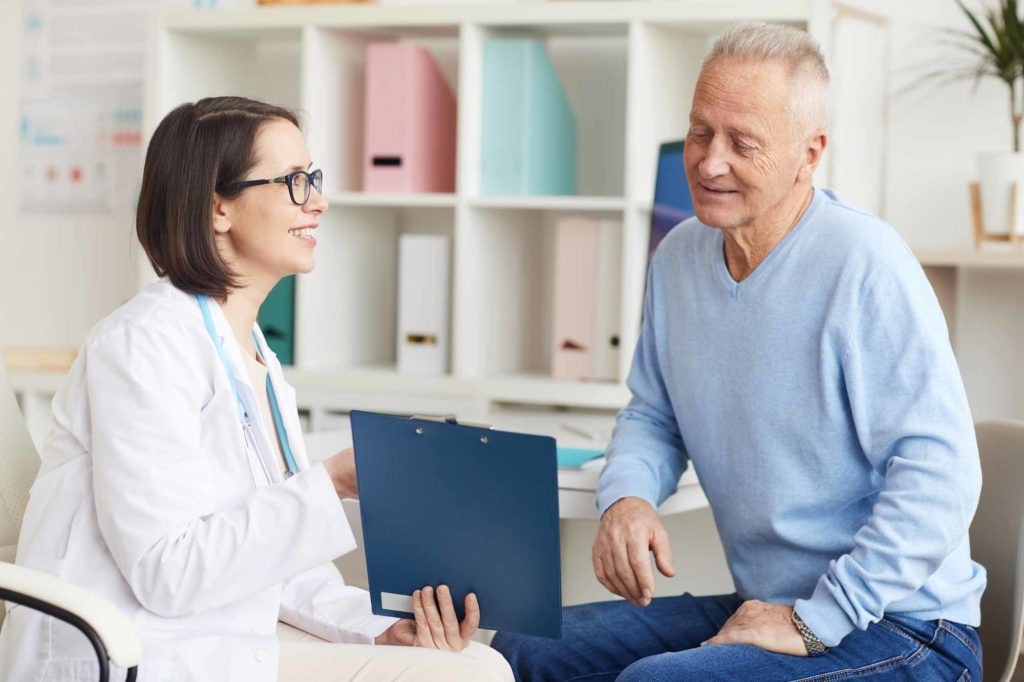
[494,25,985,682]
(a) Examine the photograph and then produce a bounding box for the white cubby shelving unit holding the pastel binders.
[145,0,880,412]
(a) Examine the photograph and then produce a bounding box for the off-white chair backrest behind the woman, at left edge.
[0,356,39,565]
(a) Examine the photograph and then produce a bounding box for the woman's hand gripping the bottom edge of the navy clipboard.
[374,585,480,651]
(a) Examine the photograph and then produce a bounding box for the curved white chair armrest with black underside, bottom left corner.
[0,561,142,669]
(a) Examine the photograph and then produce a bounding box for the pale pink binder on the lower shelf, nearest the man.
[551,217,600,381]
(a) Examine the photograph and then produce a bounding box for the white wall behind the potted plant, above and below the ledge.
[873,0,1024,420]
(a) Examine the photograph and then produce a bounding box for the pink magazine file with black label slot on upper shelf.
[362,43,456,193]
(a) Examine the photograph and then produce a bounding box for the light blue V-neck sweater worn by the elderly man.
[598,189,985,646]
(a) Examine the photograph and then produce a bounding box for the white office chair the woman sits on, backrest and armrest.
[0,358,142,682]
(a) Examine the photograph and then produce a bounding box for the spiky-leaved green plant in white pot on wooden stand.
[933,0,1024,233]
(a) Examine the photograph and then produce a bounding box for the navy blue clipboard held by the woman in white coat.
[351,412,562,638]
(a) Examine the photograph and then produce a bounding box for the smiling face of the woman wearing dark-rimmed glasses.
[213,119,328,290]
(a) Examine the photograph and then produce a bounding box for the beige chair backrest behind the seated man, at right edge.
[971,421,1024,682]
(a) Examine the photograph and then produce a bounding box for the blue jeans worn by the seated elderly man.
[492,594,981,682]
